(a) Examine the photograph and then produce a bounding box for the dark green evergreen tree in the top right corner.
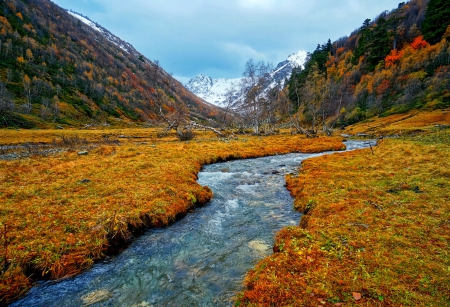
[422,0,450,44]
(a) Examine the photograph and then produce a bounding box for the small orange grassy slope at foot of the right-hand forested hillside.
[345,109,450,135]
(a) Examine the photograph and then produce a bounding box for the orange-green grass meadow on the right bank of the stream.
[236,130,450,306]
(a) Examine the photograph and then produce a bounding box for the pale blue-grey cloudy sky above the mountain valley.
[53,0,401,82]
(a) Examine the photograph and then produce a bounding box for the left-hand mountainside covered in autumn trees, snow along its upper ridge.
[0,0,217,128]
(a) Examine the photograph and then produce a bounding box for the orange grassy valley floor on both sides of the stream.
[0,110,450,306]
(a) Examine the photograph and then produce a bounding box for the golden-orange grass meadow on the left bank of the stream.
[0,129,344,305]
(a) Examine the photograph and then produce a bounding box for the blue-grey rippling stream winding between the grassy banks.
[11,141,373,307]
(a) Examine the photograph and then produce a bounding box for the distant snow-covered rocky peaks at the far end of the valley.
[185,50,307,107]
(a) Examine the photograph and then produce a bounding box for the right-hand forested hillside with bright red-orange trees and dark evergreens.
[285,0,450,131]
